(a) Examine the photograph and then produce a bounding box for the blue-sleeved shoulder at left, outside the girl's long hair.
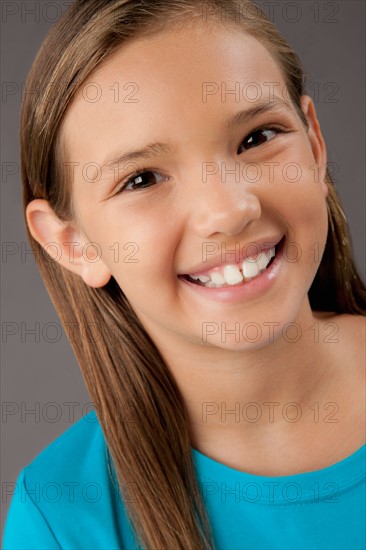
[3,411,130,550]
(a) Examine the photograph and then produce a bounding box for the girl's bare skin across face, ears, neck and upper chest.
[26,23,365,475]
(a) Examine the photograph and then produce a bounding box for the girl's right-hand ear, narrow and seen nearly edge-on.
[300,95,329,201]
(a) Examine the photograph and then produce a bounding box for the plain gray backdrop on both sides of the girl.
[1,0,366,540]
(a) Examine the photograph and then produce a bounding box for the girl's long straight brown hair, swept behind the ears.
[21,0,366,550]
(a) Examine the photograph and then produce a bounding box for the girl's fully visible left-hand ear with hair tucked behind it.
[26,199,112,288]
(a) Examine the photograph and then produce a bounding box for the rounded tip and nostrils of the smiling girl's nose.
[189,168,261,239]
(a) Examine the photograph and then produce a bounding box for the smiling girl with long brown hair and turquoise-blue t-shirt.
[4,0,366,550]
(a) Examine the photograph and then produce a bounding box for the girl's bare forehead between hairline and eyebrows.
[62,24,285,160]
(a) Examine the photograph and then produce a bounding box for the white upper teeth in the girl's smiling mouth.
[190,247,275,286]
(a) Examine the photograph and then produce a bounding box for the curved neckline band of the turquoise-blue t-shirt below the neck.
[191,443,366,505]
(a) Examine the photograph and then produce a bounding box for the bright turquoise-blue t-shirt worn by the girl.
[3,411,366,550]
